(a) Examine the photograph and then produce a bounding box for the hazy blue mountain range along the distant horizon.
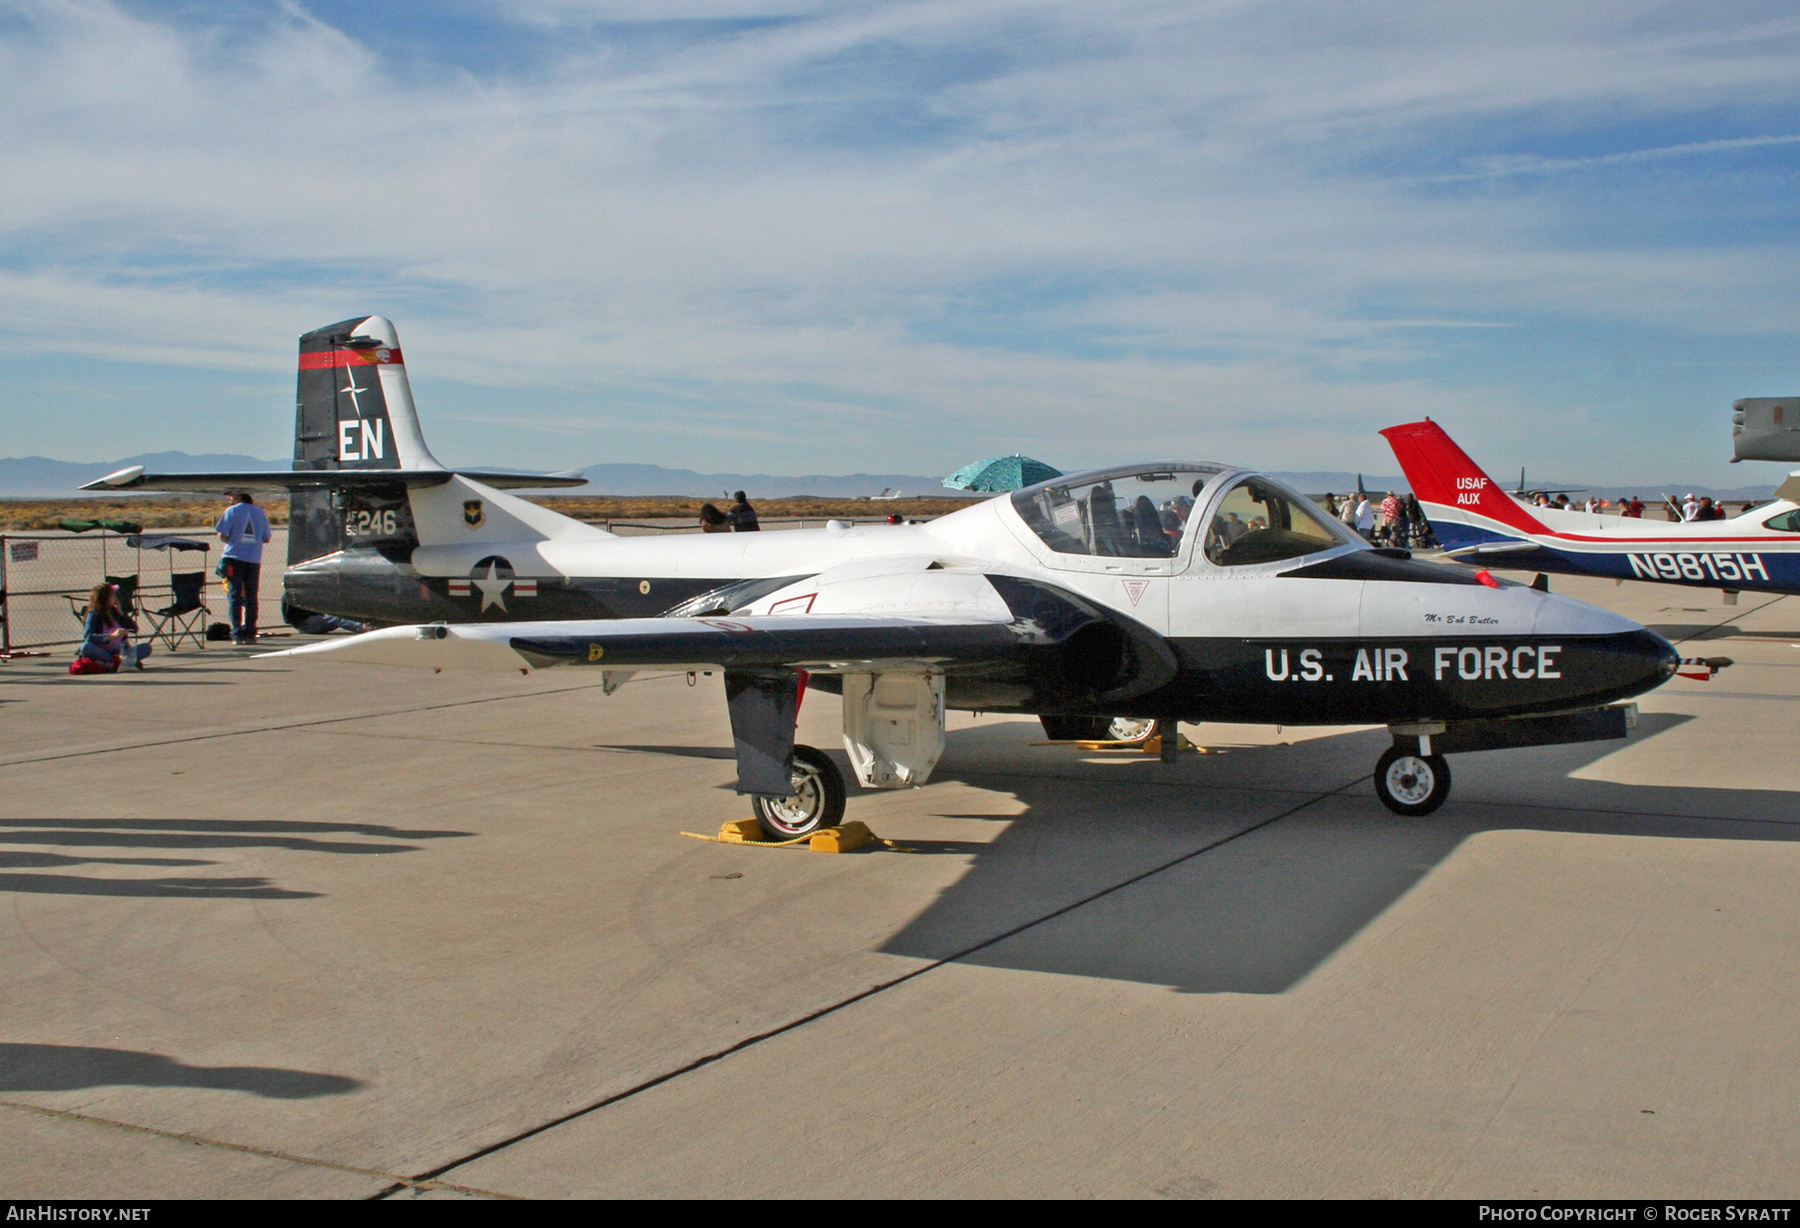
[0,452,1787,502]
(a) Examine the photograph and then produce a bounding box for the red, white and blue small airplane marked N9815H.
[1381,418,1800,601]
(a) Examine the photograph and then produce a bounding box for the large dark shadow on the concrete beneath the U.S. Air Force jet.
[882,715,1800,994]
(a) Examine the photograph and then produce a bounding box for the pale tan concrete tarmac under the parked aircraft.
[0,578,1800,1199]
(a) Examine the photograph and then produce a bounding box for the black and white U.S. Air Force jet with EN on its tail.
[87,317,1679,837]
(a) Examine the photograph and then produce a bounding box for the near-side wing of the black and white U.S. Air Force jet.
[261,614,1062,673]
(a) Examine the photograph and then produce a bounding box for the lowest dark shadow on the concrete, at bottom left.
[0,1043,362,1100]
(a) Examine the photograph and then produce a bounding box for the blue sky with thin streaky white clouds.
[0,0,1800,486]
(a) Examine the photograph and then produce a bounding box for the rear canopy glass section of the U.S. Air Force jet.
[1012,465,1222,558]
